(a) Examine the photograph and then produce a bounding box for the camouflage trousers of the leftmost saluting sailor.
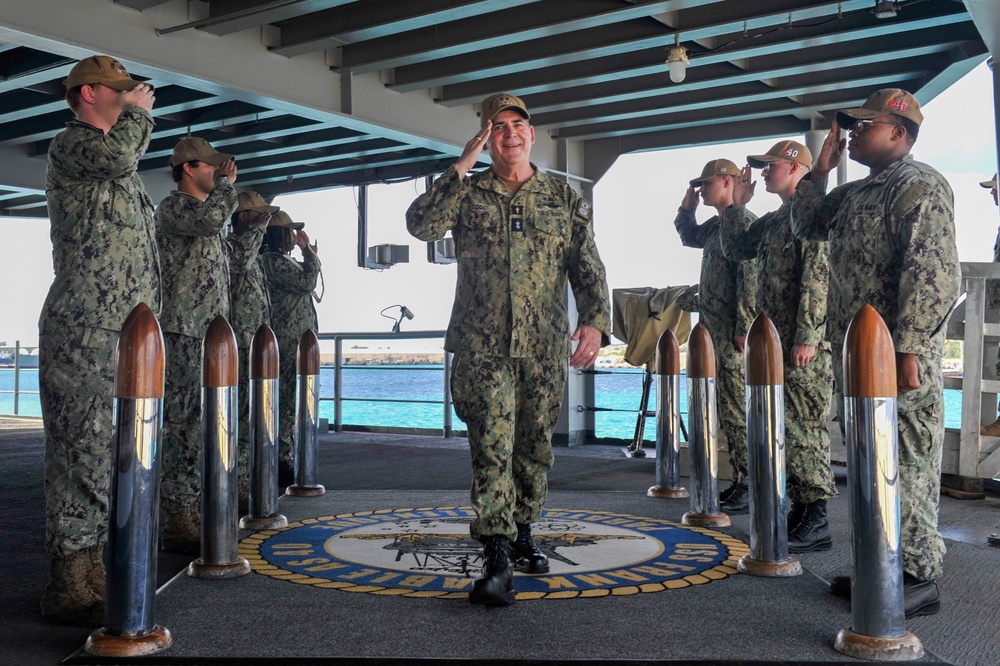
[38,327,118,557]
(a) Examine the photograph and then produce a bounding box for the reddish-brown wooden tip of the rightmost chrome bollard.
[844,304,897,398]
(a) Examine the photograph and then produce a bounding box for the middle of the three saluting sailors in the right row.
[721,141,837,553]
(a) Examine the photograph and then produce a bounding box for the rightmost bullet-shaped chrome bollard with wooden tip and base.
[833,305,924,661]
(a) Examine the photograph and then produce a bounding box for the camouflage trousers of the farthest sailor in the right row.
[713,338,749,486]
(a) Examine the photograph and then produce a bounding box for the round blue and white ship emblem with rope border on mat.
[239,507,749,600]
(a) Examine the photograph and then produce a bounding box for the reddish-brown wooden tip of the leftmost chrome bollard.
[115,303,164,398]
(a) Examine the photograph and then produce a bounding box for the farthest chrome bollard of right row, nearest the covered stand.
[646,328,688,499]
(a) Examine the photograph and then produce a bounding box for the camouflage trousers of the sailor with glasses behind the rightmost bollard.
[834,349,945,580]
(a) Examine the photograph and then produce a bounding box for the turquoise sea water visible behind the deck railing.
[0,365,962,441]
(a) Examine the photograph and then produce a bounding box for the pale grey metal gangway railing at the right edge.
[941,262,1000,479]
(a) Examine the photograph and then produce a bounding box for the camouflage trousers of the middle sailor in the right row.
[784,348,837,504]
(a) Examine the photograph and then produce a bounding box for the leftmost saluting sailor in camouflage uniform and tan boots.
[38,56,160,626]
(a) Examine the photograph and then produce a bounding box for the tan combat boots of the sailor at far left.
[41,546,107,627]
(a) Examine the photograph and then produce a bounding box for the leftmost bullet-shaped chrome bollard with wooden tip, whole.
[83,303,171,657]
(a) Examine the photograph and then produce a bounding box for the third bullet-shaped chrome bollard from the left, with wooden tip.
[240,324,288,530]
